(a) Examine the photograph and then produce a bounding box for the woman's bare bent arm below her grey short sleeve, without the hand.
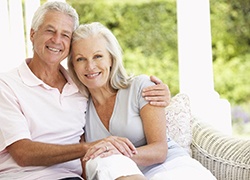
[132,104,168,166]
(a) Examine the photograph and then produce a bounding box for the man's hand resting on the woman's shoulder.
[142,76,171,107]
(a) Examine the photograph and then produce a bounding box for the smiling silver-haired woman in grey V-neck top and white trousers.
[68,23,215,180]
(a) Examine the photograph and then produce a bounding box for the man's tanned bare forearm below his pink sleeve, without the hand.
[7,139,89,166]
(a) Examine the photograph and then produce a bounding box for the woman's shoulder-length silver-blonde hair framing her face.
[68,22,133,94]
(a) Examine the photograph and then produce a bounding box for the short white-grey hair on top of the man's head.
[31,1,79,31]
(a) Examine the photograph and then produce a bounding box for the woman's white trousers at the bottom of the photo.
[86,155,216,180]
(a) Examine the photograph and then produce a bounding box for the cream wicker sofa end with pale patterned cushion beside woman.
[165,93,250,180]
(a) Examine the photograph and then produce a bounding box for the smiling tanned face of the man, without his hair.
[30,11,74,64]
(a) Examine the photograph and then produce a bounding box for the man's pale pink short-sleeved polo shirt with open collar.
[0,59,87,179]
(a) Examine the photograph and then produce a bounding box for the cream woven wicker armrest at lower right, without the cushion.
[191,120,250,180]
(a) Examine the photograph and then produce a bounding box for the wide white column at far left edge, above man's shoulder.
[0,0,25,72]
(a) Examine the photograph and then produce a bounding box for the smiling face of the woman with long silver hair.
[72,35,112,91]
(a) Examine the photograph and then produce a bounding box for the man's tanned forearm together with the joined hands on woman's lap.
[7,136,136,166]
